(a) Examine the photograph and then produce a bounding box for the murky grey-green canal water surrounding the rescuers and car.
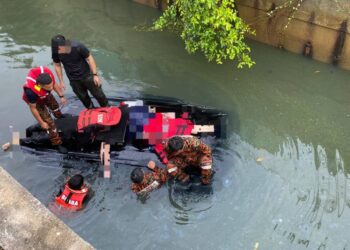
[0,0,350,250]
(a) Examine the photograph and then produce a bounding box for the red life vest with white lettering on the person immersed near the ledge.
[55,183,89,210]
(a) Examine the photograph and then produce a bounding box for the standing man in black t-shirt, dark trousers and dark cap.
[51,35,109,108]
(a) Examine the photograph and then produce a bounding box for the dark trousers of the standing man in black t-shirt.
[70,77,109,108]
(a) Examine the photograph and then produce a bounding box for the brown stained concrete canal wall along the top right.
[134,0,350,70]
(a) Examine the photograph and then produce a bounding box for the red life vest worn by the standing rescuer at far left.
[22,66,55,103]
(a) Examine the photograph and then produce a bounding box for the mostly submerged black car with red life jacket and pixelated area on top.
[20,96,227,165]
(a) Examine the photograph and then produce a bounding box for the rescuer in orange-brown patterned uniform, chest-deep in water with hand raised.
[130,161,167,195]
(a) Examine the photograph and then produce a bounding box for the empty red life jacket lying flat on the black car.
[78,107,122,132]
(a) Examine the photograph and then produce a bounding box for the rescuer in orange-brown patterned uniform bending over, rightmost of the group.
[164,136,213,185]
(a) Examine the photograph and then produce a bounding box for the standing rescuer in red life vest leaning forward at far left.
[22,66,67,153]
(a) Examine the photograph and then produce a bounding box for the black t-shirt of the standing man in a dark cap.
[52,41,91,81]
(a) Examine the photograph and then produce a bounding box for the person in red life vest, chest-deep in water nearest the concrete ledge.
[55,174,89,211]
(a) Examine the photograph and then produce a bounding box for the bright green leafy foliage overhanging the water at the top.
[153,0,254,68]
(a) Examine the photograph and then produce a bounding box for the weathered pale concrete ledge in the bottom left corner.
[0,167,94,250]
